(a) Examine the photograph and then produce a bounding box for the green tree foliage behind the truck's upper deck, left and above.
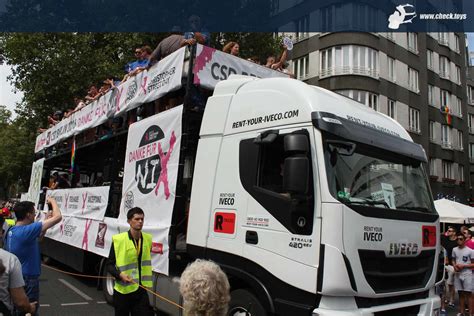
[0,33,281,194]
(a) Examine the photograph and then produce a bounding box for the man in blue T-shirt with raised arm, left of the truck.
[5,197,62,315]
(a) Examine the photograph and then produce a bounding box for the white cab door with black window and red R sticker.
[208,128,320,293]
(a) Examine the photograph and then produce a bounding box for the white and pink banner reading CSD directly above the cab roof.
[193,44,288,89]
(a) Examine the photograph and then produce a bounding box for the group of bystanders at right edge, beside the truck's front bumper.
[438,226,474,316]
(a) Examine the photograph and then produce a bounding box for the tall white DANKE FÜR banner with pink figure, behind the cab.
[119,105,183,274]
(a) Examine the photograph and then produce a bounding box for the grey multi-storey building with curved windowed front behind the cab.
[286,32,474,203]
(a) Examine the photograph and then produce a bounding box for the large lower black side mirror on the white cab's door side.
[283,156,309,194]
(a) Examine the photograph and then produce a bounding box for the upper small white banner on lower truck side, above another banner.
[46,186,110,221]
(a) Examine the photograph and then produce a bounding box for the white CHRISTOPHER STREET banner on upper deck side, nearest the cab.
[115,47,186,115]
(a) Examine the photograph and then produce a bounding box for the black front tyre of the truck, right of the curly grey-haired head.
[227,289,267,316]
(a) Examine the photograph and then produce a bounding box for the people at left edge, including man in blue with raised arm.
[0,197,62,316]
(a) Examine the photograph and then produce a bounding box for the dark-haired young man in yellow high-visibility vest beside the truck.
[107,207,153,316]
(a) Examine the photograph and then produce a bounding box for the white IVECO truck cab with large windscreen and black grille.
[186,76,440,315]
